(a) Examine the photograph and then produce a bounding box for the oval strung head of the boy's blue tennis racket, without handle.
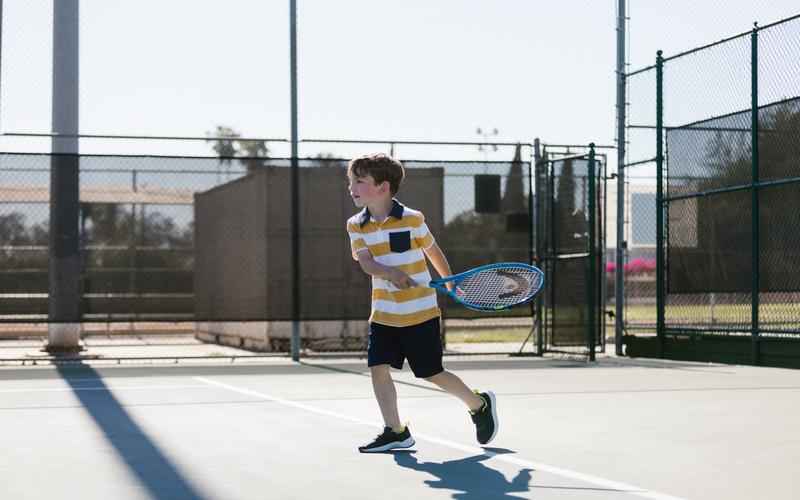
[457,267,541,307]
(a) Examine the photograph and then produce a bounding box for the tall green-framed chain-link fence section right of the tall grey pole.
[626,16,800,364]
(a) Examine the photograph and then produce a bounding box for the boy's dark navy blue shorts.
[367,318,444,378]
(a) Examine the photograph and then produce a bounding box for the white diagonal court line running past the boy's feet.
[193,377,686,500]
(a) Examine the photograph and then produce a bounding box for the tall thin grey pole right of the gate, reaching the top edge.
[614,0,628,356]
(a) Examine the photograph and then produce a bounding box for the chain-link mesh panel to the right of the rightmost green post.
[758,20,800,336]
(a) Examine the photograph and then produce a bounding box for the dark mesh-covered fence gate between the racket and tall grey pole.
[536,147,606,360]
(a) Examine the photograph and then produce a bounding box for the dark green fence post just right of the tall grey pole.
[656,50,665,358]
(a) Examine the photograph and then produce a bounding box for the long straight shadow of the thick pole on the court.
[57,365,205,500]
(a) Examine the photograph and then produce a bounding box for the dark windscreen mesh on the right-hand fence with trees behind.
[669,99,800,292]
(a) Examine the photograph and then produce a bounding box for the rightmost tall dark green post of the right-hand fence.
[750,24,761,365]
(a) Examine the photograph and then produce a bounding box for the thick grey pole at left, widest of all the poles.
[46,0,81,353]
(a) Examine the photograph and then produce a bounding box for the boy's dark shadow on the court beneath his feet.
[394,451,532,500]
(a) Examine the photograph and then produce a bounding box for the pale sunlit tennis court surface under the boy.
[0,357,800,500]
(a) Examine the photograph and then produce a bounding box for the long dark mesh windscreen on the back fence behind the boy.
[0,153,531,322]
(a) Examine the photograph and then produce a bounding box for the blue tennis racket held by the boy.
[428,262,544,311]
